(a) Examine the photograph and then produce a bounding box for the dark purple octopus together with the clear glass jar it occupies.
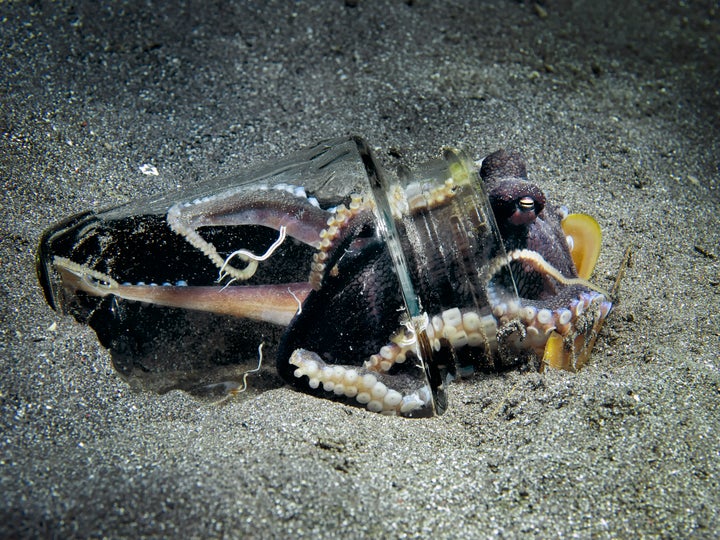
[37,138,612,417]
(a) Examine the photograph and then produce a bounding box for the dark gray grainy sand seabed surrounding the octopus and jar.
[0,0,720,538]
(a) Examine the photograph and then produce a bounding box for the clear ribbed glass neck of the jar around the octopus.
[362,143,519,406]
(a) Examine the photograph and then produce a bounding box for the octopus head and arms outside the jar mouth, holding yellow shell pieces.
[480,150,611,369]
